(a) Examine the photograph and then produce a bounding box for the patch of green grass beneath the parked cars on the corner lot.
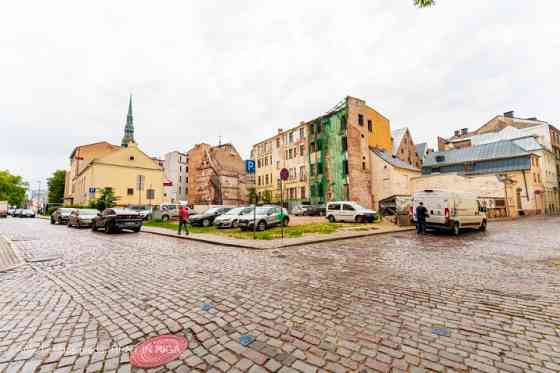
[144,220,373,240]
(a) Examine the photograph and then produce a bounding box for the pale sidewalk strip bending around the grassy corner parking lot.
[142,222,416,250]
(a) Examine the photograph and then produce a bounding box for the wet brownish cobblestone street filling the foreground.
[0,218,560,373]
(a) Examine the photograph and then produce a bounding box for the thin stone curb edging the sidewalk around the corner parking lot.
[141,227,416,250]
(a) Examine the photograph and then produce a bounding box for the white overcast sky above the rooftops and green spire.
[0,0,560,185]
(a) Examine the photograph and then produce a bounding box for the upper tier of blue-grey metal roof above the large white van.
[424,140,530,167]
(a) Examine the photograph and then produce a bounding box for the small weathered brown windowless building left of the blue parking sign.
[187,144,249,206]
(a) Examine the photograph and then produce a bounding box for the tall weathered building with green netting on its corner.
[251,97,392,206]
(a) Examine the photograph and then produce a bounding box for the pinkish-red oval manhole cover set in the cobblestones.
[130,335,189,368]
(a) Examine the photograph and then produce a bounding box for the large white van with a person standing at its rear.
[412,190,488,235]
